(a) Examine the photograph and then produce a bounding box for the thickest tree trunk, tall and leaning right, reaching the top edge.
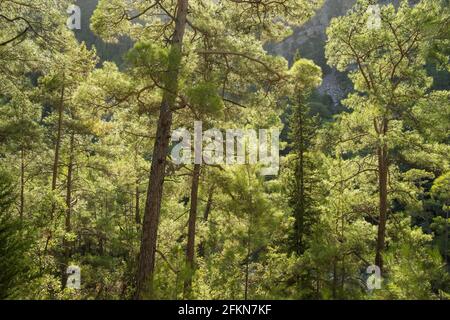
[135,0,188,299]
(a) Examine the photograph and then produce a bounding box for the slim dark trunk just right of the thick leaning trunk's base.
[183,164,200,299]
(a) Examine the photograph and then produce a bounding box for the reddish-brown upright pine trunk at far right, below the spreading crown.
[375,118,389,271]
